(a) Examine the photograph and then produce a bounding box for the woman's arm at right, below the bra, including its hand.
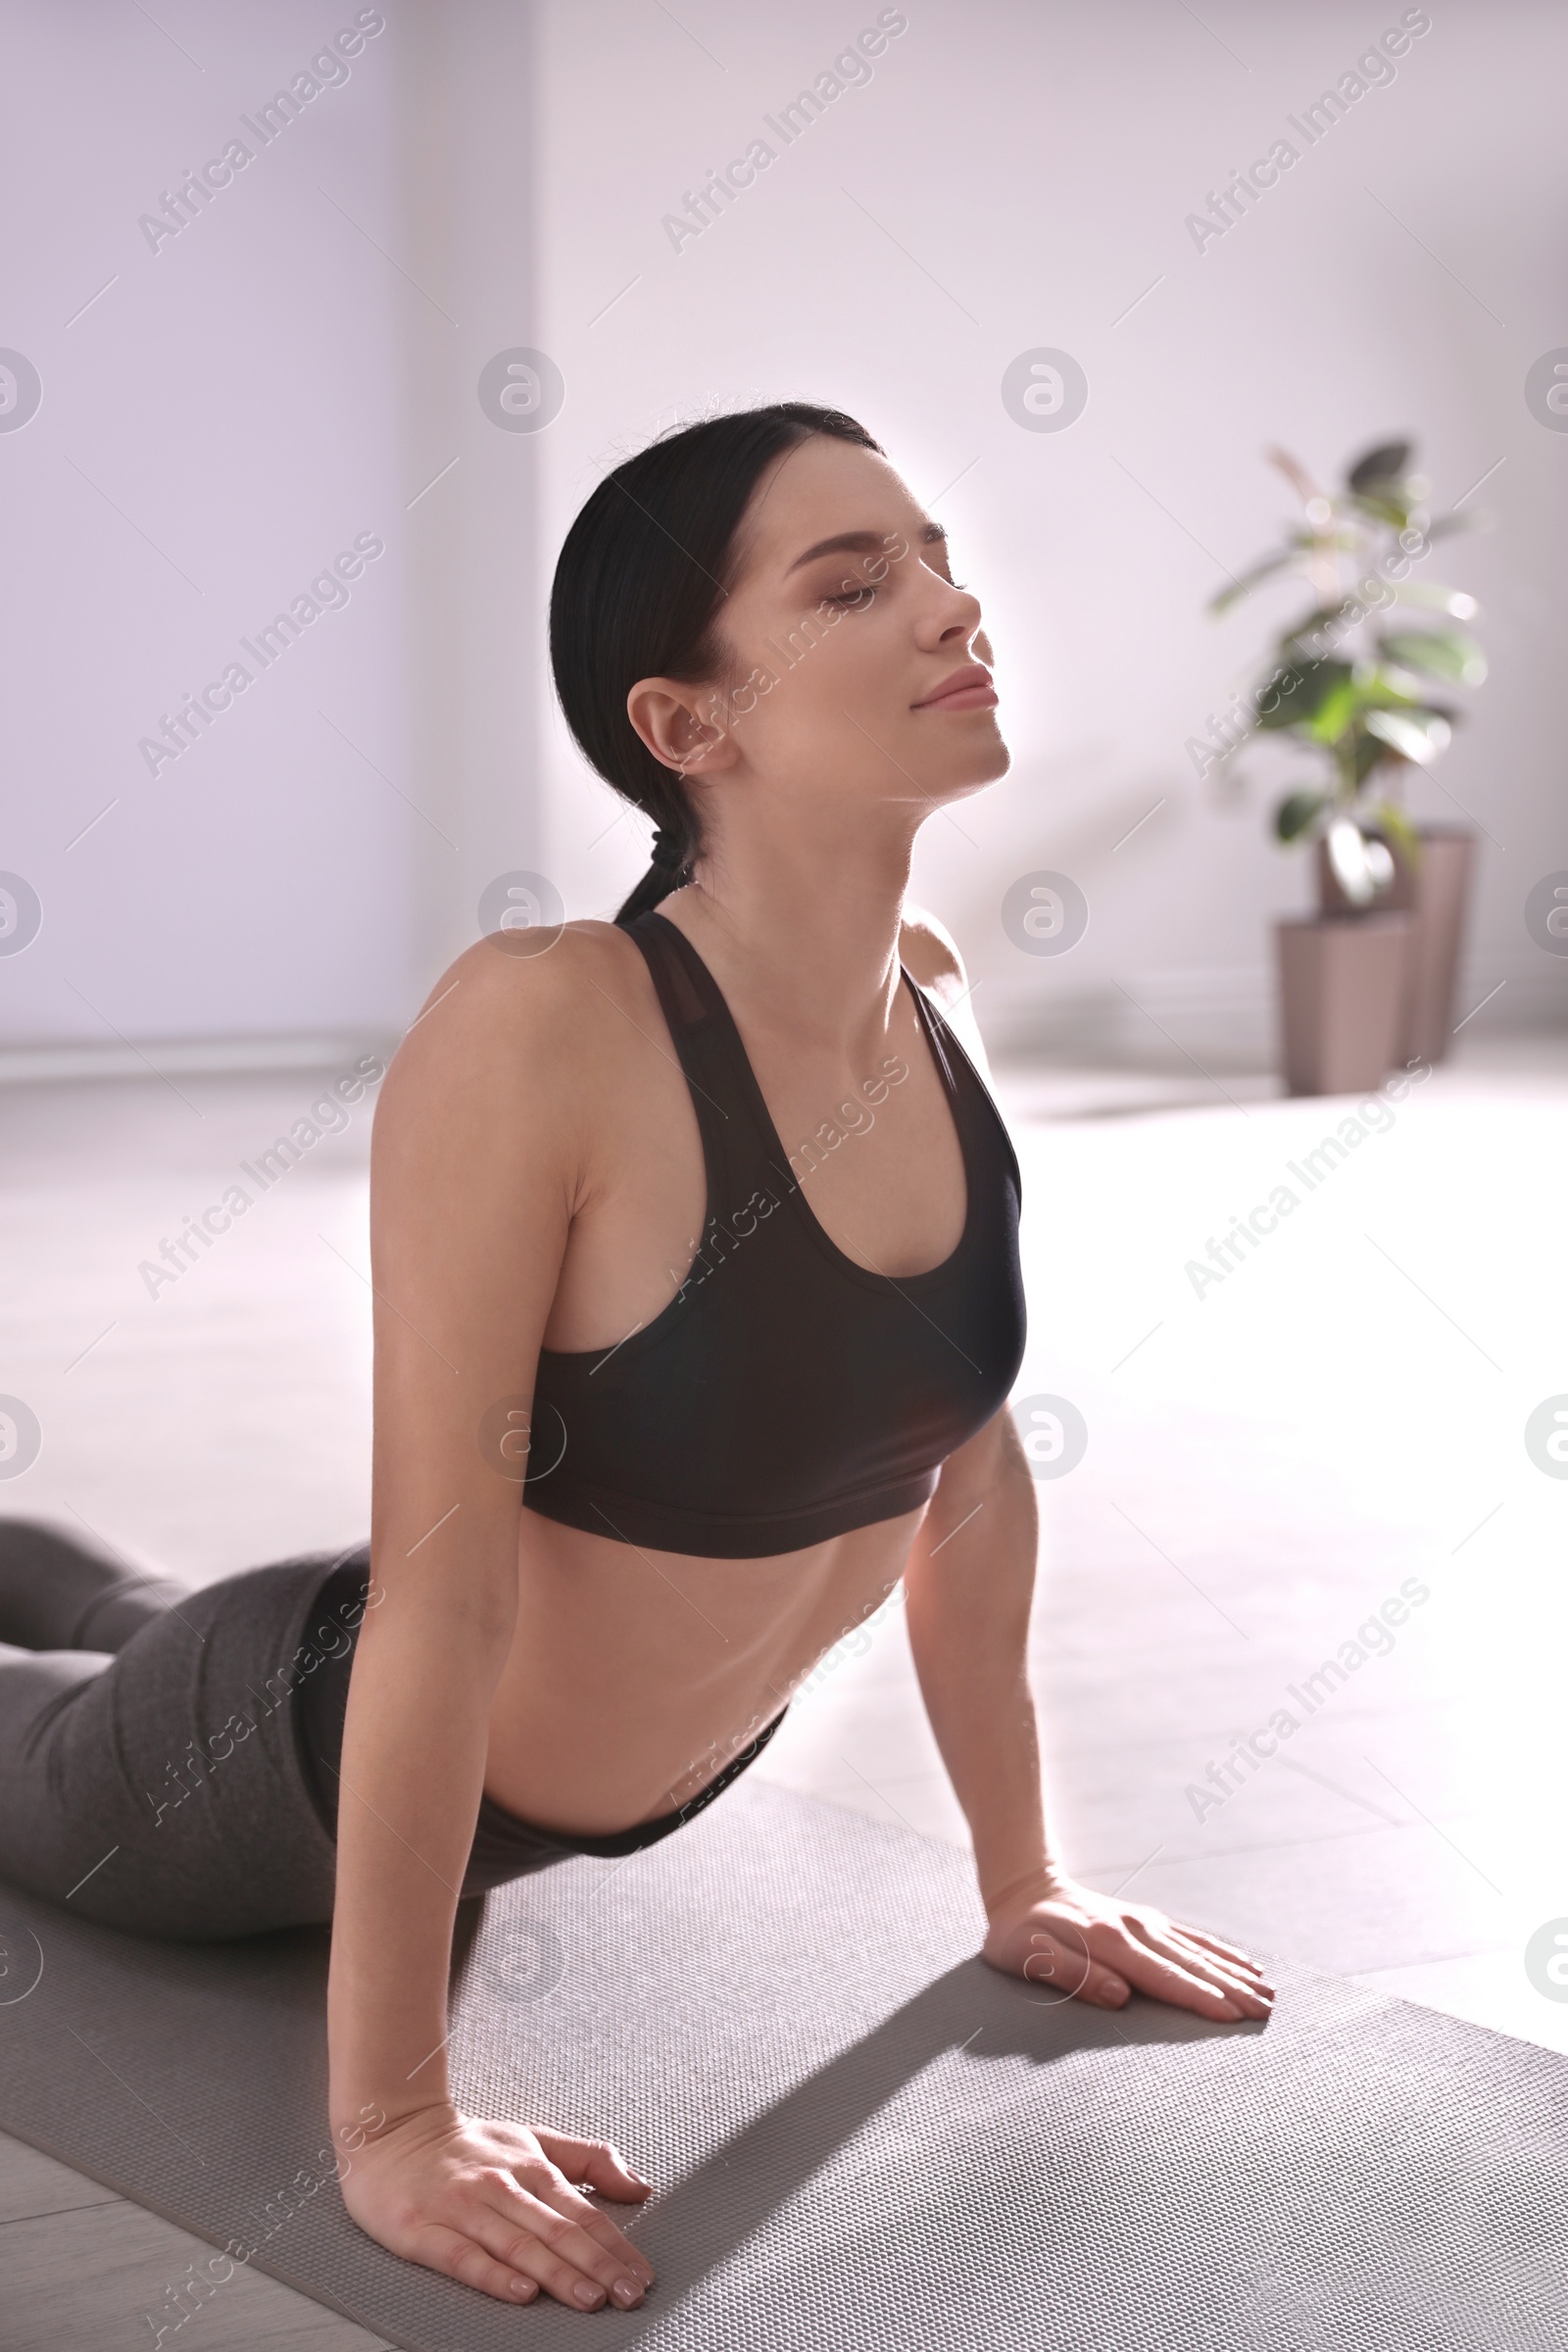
[906,1406,1272,2018]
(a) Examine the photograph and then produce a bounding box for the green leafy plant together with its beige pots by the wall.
[1208,440,1486,1094]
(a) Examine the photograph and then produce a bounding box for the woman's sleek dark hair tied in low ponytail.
[550,400,882,922]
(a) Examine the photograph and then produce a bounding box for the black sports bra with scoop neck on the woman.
[522,912,1025,1559]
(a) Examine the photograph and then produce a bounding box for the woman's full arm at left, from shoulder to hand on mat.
[326,934,651,2307]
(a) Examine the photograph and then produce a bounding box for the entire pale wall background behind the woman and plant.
[0,0,1568,1058]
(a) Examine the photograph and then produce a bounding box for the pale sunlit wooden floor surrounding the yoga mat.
[0,1042,1568,2352]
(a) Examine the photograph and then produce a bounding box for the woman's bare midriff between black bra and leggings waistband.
[484,1510,921,1837]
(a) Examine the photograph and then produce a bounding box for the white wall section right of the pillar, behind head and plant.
[538,0,1568,1049]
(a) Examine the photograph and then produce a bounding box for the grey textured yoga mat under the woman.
[0,1781,1568,2352]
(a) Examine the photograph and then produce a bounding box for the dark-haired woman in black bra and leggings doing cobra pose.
[0,402,1272,2310]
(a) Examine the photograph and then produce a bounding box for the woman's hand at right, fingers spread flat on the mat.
[980,1877,1274,2018]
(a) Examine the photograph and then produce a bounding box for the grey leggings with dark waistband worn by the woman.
[0,1519,780,1942]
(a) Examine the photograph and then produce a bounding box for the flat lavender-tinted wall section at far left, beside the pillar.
[0,0,420,1052]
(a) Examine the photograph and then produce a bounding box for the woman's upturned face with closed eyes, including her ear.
[627,435,1008,823]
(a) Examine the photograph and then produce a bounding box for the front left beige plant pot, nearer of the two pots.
[1274,912,1415,1094]
